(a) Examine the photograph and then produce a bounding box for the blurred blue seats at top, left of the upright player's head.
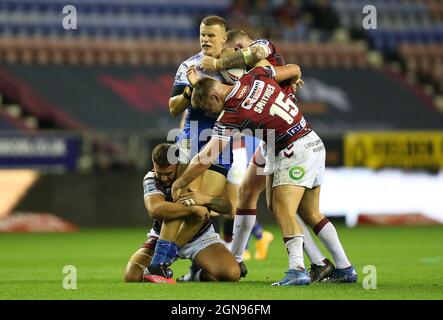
[0,0,230,38]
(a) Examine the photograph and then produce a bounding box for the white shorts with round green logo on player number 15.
[265,131,326,189]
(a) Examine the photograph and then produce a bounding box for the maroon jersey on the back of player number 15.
[215,67,311,151]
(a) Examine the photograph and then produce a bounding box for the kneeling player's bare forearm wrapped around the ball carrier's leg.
[144,193,209,220]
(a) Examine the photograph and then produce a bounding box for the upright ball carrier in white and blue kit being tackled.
[148,16,237,275]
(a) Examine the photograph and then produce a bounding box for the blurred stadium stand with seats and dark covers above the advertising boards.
[0,0,443,169]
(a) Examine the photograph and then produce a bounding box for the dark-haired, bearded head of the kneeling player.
[152,143,179,187]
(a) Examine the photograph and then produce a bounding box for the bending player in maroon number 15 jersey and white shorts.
[172,62,356,285]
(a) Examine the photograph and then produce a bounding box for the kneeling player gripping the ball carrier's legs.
[124,143,240,283]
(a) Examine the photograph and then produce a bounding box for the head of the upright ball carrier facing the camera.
[200,16,227,58]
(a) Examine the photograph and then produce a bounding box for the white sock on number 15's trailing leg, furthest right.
[317,221,351,269]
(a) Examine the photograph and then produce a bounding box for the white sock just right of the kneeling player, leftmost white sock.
[231,209,256,262]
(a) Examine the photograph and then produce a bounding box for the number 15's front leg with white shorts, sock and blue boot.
[266,131,332,285]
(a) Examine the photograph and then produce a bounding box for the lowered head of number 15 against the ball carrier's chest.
[191,77,225,113]
